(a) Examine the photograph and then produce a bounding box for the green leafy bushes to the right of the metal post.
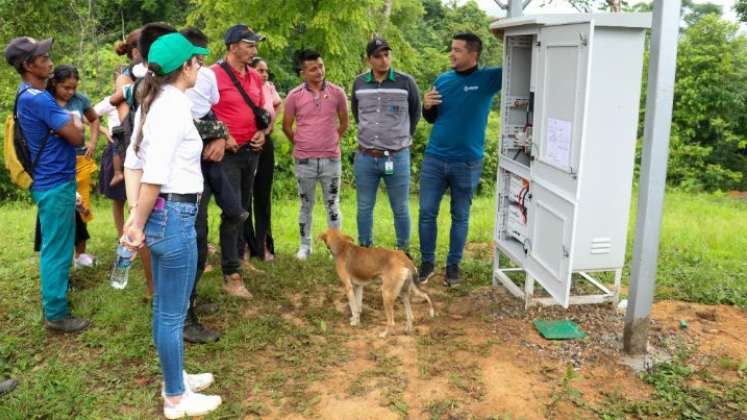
[669,14,747,190]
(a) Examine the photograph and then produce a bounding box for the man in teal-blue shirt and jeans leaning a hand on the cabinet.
[418,32,502,286]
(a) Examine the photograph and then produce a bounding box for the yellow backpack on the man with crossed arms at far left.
[3,88,52,190]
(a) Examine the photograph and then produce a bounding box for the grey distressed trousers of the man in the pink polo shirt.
[296,158,342,249]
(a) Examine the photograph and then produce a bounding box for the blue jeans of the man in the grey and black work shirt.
[353,149,410,249]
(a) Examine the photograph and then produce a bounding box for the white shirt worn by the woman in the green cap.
[124,85,202,194]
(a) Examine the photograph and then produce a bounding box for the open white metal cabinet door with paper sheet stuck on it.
[526,22,593,307]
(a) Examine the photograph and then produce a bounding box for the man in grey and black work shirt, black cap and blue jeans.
[352,38,420,255]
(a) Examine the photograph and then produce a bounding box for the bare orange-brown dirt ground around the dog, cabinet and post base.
[253,285,747,419]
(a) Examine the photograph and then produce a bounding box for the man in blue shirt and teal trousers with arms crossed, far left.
[5,37,88,332]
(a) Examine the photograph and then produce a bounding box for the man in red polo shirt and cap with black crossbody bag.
[207,25,265,299]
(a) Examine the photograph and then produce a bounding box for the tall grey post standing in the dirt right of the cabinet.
[623,0,681,355]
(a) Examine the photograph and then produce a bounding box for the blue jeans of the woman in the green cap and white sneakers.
[145,201,197,397]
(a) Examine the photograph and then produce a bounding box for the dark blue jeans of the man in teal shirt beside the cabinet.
[418,154,482,265]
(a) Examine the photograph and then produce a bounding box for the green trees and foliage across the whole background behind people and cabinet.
[0,0,747,199]
